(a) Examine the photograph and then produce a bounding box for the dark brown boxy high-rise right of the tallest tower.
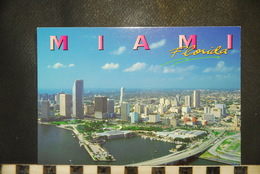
[95,95,107,118]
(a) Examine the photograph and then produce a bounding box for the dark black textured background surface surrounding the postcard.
[0,0,260,164]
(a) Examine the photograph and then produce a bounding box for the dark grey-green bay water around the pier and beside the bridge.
[38,124,226,165]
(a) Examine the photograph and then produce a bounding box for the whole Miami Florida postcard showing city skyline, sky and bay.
[37,27,241,166]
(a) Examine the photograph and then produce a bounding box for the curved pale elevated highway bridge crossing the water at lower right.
[128,132,224,166]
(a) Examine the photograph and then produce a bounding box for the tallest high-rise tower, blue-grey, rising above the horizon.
[72,80,84,117]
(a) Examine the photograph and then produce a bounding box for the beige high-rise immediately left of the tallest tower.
[59,94,72,117]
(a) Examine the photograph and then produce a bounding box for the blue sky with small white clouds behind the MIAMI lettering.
[37,27,241,90]
